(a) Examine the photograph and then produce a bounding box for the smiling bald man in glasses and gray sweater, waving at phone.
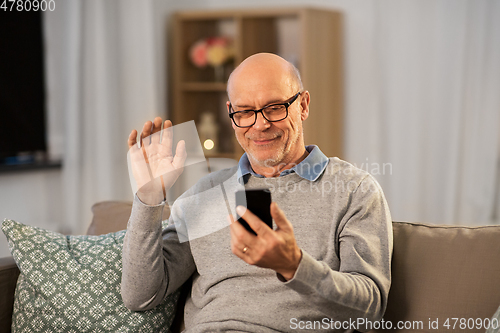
[122,53,392,332]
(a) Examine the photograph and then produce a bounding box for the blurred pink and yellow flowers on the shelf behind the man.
[189,36,234,68]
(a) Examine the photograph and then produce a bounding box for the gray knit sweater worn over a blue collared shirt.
[122,158,392,332]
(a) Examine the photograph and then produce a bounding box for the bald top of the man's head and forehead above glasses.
[227,53,304,99]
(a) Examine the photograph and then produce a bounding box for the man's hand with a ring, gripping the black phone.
[230,202,302,280]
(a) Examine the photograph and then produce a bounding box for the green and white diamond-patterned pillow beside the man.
[2,220,179,333]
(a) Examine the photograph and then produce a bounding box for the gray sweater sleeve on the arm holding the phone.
[286,176,392,330]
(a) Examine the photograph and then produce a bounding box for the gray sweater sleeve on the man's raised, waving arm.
[121,196,195,311]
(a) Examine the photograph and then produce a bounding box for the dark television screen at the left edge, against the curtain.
[0,10,46,163]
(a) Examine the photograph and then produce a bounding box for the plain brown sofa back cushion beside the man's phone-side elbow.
[384,222,500,332]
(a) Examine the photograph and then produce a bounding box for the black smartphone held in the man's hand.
[236,189,273,235]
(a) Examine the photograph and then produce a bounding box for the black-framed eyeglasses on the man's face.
[229,91,301,127]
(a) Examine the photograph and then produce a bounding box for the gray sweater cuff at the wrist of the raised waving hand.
[127,194,165,232]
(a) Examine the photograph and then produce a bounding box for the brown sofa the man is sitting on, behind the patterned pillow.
[0,201,500,332]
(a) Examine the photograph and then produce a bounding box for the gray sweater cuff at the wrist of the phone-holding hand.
[284,250,326,295]
